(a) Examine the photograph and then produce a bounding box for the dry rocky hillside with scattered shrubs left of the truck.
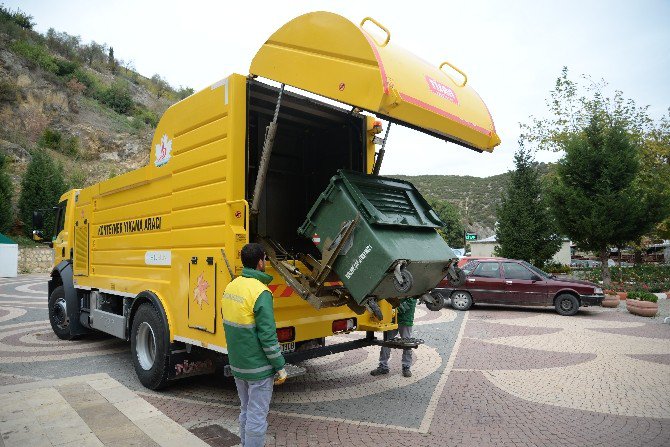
[0,6,192,201]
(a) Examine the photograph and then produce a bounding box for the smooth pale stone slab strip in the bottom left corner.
[0,374,208,447]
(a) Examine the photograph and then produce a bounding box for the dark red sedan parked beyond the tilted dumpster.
[432,258,605,315]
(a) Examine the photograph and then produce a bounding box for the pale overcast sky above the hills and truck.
[6,0,670,177]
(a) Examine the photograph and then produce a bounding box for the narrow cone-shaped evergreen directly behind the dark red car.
[495,145,561,268]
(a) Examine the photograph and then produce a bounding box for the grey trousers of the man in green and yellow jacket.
[235,376,274,447]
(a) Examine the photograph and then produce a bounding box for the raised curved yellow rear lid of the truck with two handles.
[249,11,500,152]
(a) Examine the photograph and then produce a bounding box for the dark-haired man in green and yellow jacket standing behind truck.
[221,244,287,447]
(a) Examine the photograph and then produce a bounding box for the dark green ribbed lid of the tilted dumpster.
[333,170,446,228]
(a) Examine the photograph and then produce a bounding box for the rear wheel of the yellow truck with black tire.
[130,303,170,390]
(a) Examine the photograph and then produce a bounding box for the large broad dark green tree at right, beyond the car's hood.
[549,112,667,287]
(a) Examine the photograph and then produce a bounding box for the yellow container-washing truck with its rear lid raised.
[35,12,500,389]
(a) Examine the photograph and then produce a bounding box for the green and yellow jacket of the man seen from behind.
[221,267,285,380]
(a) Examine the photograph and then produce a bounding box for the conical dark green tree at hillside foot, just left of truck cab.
[19,149,67,237]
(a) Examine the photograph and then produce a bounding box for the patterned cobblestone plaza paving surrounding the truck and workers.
[0,276,670,447]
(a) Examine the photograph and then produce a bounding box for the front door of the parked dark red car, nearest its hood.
[502,261,546,306]
